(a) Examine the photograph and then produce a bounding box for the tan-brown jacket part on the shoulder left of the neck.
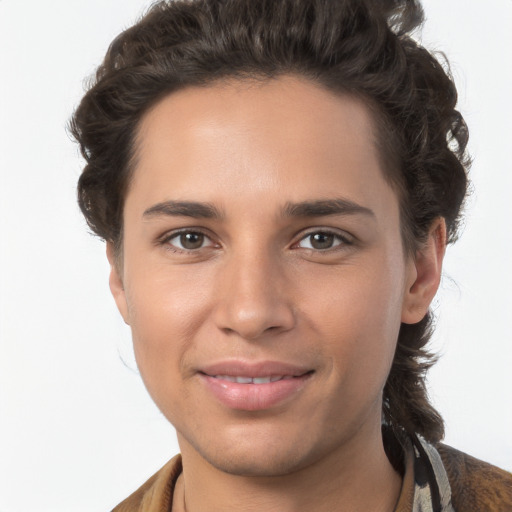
[112,455,182,512]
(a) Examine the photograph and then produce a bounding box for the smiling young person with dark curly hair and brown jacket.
[73,0,512,512]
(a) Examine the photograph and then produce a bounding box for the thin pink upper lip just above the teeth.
[199,360,313,378]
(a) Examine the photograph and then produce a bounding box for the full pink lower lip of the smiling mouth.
[201,373,311,411]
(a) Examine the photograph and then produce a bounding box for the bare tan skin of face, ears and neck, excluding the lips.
[108,76,446,512]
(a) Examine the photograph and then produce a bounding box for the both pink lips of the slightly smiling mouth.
[198,361,314,411]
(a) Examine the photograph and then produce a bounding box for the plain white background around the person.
[0,0,512,512]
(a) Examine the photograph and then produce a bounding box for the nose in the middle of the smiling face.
[214,253,295,340]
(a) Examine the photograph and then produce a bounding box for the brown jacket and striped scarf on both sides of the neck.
[112,436,512,512]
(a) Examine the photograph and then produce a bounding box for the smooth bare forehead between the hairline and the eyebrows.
[127,76,396,218]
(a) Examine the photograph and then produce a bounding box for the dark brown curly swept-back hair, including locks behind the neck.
[70,0,469,442]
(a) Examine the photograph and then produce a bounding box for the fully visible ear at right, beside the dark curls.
[402,217,446,324]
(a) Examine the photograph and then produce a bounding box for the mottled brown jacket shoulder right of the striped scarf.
[437,444,512,512]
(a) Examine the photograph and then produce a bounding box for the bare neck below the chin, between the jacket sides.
[173,429,401,512]
